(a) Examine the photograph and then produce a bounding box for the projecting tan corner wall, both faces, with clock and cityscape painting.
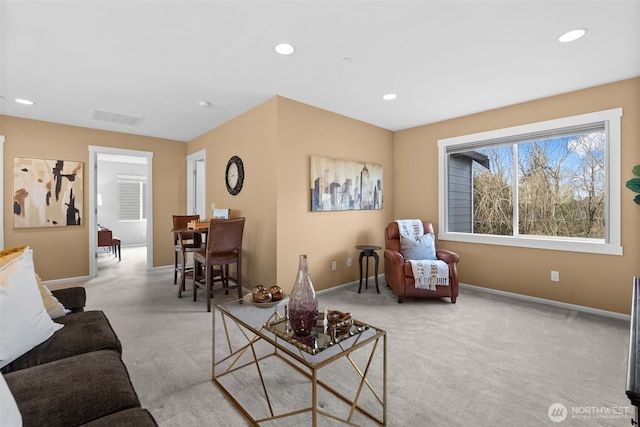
[188,97,393,292]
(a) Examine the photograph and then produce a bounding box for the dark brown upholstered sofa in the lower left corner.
[0,287,157,427]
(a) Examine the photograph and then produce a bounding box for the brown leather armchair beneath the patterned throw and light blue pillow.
[384,221,460,303]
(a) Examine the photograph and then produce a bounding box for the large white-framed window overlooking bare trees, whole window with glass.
[438,109,622,255]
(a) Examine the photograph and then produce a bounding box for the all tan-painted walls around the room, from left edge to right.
[0,78,640,313]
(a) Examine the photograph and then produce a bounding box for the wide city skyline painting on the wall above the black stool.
[311,156,383,212]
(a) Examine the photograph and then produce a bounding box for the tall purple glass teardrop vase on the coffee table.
[288,255,318,337]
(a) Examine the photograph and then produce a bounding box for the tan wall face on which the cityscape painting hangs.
[277,98,394,290]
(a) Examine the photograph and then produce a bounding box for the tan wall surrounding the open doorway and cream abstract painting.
[0,116,186,280]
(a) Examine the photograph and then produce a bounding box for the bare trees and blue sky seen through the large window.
[458,130,606,239]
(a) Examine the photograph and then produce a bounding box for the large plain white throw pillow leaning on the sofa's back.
[0,249,61,368]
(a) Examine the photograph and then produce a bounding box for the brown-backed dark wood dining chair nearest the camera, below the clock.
[193,217,245,311]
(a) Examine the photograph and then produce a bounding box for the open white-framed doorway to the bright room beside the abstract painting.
[89,146,153,278]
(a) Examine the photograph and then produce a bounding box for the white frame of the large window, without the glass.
[438,108,622,255]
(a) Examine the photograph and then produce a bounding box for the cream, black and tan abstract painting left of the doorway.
[13,157,84,228]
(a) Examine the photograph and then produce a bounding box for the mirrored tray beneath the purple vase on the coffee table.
[263,318,369,355]
